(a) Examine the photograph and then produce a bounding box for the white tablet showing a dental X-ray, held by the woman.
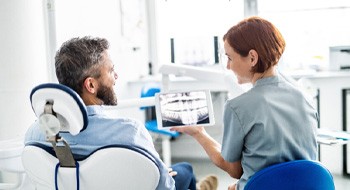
[155,90,215,129]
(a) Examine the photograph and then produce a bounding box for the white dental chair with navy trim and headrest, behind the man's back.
[22,83,160,190]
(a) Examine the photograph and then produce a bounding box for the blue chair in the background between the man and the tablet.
[141,83,180,166]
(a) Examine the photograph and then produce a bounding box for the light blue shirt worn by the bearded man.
[25,106,175,190]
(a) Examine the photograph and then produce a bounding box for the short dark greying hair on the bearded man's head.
[55,36,109,94]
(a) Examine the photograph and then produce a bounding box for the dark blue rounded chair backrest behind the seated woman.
[244,160,335,190]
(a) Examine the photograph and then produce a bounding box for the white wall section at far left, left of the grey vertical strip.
[0,0,48,140]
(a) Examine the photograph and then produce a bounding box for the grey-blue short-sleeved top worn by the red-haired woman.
[221,75,318,190]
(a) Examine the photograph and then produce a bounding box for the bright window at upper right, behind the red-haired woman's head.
[258,0,350,71]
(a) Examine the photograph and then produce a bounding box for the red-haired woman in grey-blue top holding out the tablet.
[172,17,318,190]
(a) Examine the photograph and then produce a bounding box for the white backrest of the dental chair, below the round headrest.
[22,145,160,190]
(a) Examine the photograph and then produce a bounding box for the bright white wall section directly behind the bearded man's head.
[55,0,148,99]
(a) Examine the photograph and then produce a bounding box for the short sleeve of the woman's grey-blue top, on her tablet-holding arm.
[221,103,244,162]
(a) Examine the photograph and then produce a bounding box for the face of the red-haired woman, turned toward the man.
[224,40,253,84]
